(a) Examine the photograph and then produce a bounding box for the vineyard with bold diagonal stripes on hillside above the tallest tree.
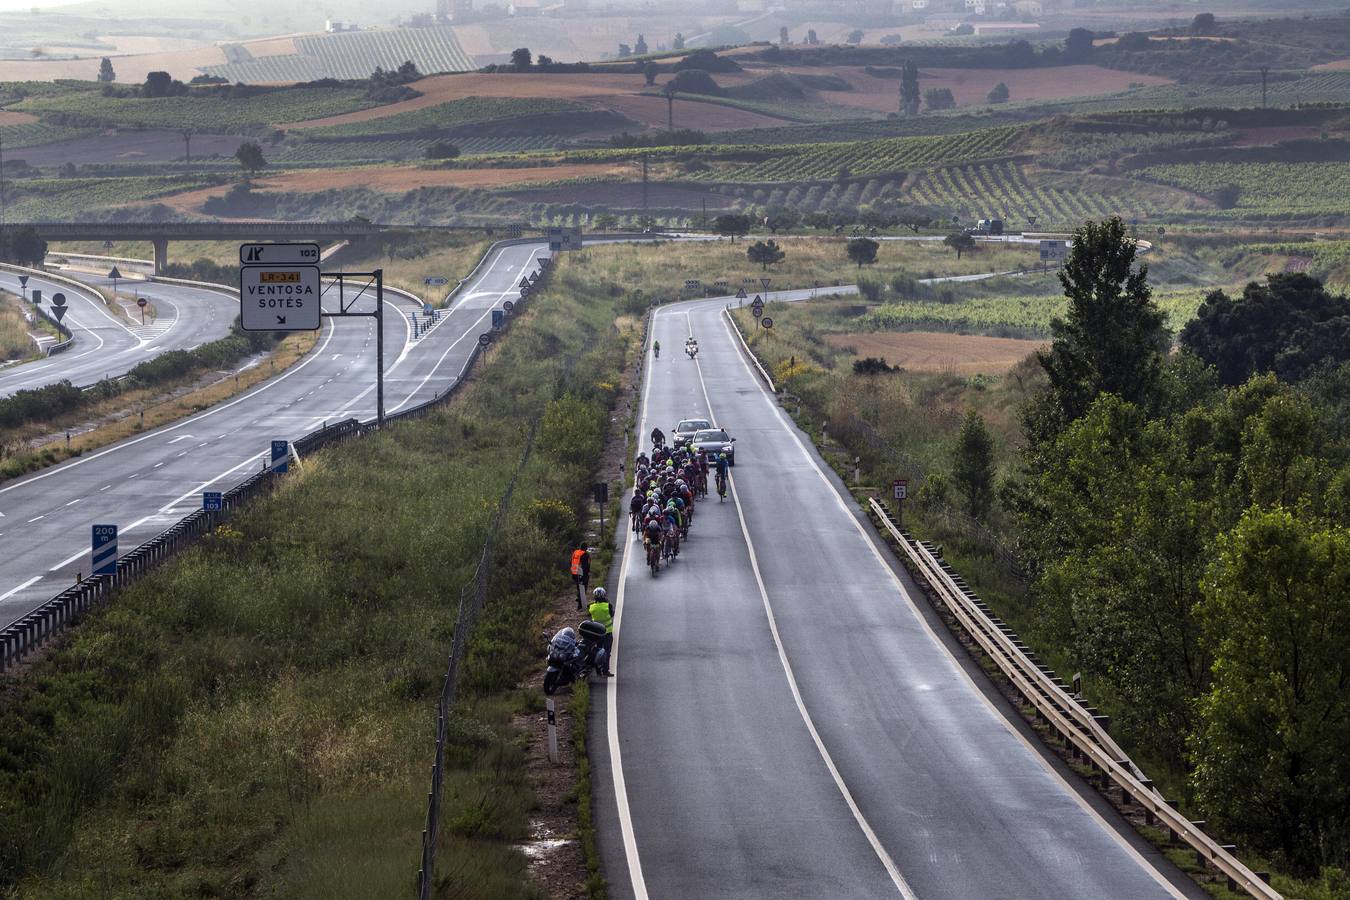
[905,162,1188,228]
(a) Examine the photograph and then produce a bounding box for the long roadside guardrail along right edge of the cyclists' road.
[868,497,1283,900]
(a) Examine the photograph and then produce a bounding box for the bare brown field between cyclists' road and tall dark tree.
[826,331,1045,375]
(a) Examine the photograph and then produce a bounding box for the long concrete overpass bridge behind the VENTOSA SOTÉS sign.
[24,221,391,273]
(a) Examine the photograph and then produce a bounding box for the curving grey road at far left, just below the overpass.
[0,271,239,397]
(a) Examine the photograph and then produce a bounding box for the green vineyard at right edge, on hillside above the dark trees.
[1137,162,1350,216]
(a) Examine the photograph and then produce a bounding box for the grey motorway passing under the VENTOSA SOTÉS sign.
[0,243,548,626]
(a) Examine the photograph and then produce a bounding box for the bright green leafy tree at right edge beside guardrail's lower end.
[1192,507,1350,874]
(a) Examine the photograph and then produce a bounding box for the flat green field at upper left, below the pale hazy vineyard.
[11,89,378,134]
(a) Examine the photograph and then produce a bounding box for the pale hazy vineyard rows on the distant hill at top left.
[203,26,477,83]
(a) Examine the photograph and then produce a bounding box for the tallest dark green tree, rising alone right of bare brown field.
[1026,219,1170,444]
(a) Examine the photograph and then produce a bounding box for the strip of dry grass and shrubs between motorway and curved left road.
[0,332,319,482]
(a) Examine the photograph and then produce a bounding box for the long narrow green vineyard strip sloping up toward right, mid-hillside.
[706,127,1022,182]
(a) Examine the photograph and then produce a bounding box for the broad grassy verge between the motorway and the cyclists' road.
[0,244,632,899]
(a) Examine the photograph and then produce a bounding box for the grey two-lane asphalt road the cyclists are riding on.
[591,292,1203,900]
